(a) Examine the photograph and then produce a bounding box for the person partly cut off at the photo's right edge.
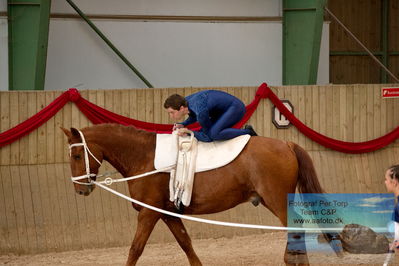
[385,164,399,251]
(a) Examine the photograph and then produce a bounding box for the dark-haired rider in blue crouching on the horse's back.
[164,90,257,142]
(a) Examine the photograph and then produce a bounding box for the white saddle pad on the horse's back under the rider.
[154,133,251,172]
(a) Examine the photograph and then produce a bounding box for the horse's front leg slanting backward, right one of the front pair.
[162,216,202,265]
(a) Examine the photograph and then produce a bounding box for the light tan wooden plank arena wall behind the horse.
[0,85,399,254]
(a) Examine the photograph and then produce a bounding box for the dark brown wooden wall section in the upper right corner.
[327,0,399,84]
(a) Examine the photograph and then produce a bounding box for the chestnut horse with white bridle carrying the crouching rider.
[62,124,323,265]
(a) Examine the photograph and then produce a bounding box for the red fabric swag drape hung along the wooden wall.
[0,83,399,153]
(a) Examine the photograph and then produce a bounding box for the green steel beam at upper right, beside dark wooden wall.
[283,0,327,85]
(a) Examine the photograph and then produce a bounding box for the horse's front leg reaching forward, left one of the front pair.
[126,208,161,266]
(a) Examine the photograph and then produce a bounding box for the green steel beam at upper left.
[7,0,51,90]
